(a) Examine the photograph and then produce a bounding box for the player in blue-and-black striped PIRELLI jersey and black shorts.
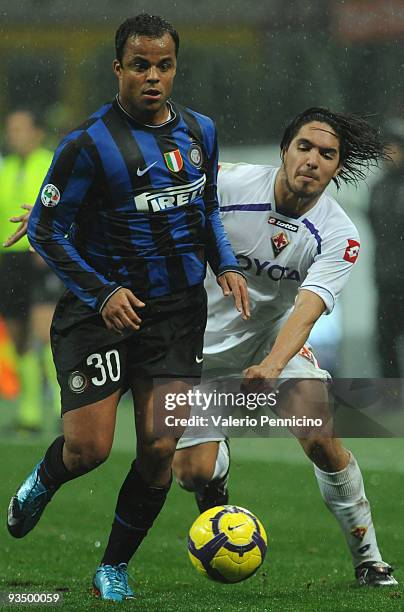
[8,14,249,601]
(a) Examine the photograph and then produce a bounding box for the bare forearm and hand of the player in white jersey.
[243,289,325,387]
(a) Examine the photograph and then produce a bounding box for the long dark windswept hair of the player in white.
[280,106,388,188]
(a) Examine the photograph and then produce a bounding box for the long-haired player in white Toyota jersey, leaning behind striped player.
[174,108,397,586]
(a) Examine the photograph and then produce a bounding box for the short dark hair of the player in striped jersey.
[115,13,180,63]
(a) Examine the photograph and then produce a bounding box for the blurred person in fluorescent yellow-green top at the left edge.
[0,109,60,431]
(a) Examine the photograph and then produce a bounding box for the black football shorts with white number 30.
[51,285,207,414]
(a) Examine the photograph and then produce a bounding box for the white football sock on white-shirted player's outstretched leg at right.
[314,453,382,567]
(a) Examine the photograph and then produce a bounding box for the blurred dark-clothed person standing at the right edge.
[369,118,404,378]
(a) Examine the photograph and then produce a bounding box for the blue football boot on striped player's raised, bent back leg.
[7,461,57,538]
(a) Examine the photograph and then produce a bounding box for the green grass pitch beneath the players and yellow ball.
[0,428,404,612]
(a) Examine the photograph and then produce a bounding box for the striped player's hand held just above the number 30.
[101,287,146,334]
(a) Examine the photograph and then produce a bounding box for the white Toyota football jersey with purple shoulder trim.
[204,164,359,354]
